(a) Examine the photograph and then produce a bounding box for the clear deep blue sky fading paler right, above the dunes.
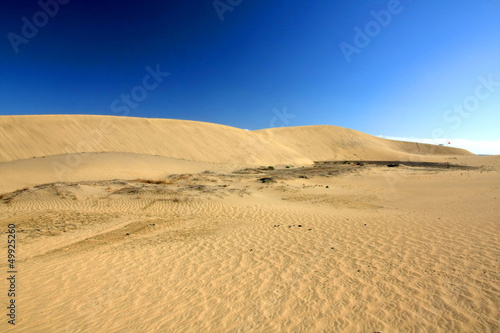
[0,0,500,154]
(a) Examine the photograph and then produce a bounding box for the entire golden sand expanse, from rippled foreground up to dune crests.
[0,116,500,332]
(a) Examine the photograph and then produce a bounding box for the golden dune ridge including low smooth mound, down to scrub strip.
[0,115,473,192]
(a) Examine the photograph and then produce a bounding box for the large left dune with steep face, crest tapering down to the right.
[0,115,311,164]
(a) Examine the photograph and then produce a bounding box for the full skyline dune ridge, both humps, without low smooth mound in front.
[0,115,473,165]
